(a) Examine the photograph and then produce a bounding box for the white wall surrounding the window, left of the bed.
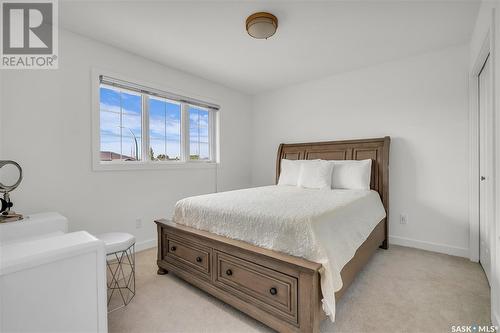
[1,31,251,249]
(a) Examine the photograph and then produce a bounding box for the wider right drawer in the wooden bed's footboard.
[214,251,298,324]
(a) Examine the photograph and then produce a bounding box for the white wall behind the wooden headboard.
[252,45,469,257]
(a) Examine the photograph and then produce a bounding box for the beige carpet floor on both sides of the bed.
[108,246,490,332]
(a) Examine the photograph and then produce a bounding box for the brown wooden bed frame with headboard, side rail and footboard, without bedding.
[155,137,390,332]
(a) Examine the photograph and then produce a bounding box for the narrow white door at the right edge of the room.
[478,57,492,281]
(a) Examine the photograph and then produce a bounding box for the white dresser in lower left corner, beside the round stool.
[0,213,107,332]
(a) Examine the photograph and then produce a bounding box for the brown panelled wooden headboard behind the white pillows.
[276,136,391,211]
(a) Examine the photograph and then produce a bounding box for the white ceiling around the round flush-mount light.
[60,0,479,94]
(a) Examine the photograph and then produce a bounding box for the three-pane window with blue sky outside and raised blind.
[94,75,219,169]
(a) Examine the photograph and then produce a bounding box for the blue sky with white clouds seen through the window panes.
[100,87,209,158]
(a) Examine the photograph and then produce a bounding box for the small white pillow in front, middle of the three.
[297,160,333,189]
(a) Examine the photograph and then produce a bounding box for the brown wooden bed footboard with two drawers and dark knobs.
[155,220,322,332]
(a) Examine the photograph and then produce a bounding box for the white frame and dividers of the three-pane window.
[91,69,220,171]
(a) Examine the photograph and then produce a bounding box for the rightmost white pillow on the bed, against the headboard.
[332,159,372,190]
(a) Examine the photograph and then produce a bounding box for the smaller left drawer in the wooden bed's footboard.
[164,234,212,278]
